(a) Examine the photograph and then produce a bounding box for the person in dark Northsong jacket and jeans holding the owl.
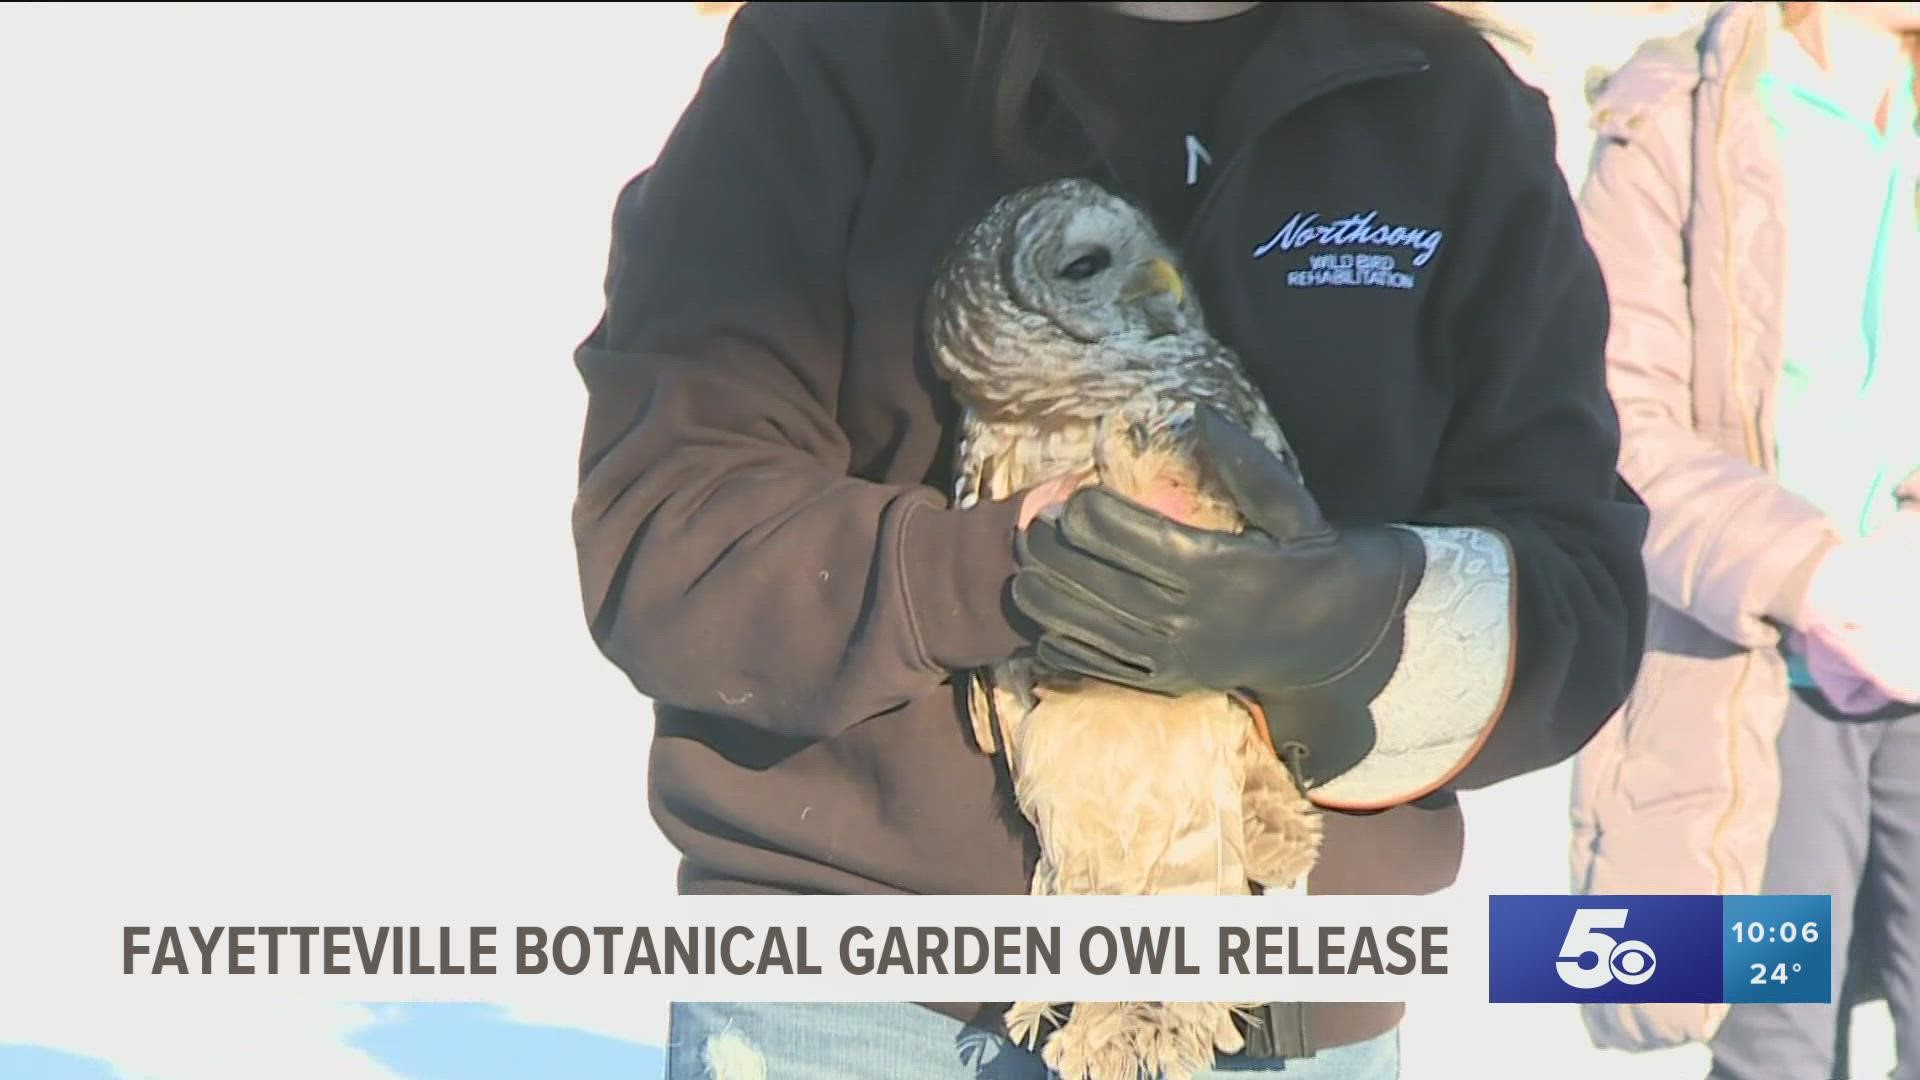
[574,4,1647,1080]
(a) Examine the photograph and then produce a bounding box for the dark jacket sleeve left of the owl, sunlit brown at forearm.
[572,6,1020,738]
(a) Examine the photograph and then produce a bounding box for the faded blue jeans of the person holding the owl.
[666,1001,1400,1080]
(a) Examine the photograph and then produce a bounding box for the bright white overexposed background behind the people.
[0,4,1891,1080]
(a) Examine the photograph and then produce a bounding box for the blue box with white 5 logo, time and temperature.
[1488,896,1834,1005]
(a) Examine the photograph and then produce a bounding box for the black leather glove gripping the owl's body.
[1012,409,1427,786]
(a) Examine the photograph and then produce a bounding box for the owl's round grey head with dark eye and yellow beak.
[929,179,1204,399]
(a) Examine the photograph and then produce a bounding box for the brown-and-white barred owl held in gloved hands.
[927,179,1321,1080]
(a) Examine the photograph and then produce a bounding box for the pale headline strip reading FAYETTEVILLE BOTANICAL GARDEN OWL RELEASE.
[112,896,1459,1001]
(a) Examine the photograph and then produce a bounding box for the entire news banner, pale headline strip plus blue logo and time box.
[93,896,1832,1005]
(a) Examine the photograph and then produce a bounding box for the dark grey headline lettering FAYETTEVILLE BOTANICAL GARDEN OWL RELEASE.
[121,924,1448,976]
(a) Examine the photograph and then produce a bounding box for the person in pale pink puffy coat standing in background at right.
[1572,4,1920,1080]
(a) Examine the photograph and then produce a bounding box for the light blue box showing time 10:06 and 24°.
[1722,896,1834,1003]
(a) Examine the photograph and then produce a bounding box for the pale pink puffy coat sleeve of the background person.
[1580,94,1837,648]
